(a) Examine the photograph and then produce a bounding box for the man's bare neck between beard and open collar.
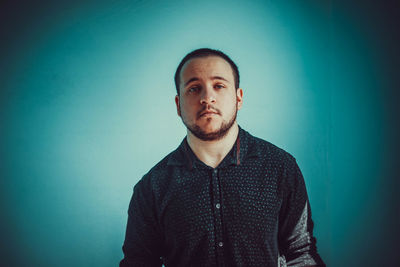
[187,122,239,168]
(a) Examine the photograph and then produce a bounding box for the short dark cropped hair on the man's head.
[175,48,240,96]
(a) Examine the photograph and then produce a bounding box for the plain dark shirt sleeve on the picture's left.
[120,179,162,267]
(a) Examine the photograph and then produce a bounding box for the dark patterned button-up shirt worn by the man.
[120,127,325,267]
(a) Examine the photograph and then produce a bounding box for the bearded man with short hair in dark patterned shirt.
[120,49,325,266]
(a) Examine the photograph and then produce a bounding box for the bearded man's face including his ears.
[175,56,243,141]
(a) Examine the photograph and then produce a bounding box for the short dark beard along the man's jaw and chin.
[182,104,238,141]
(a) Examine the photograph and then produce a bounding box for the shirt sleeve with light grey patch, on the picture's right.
[278,159,326,267]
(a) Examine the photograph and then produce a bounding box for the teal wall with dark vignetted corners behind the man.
[0,0,400,266]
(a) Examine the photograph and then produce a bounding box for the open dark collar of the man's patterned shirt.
[167,126,261,170]
